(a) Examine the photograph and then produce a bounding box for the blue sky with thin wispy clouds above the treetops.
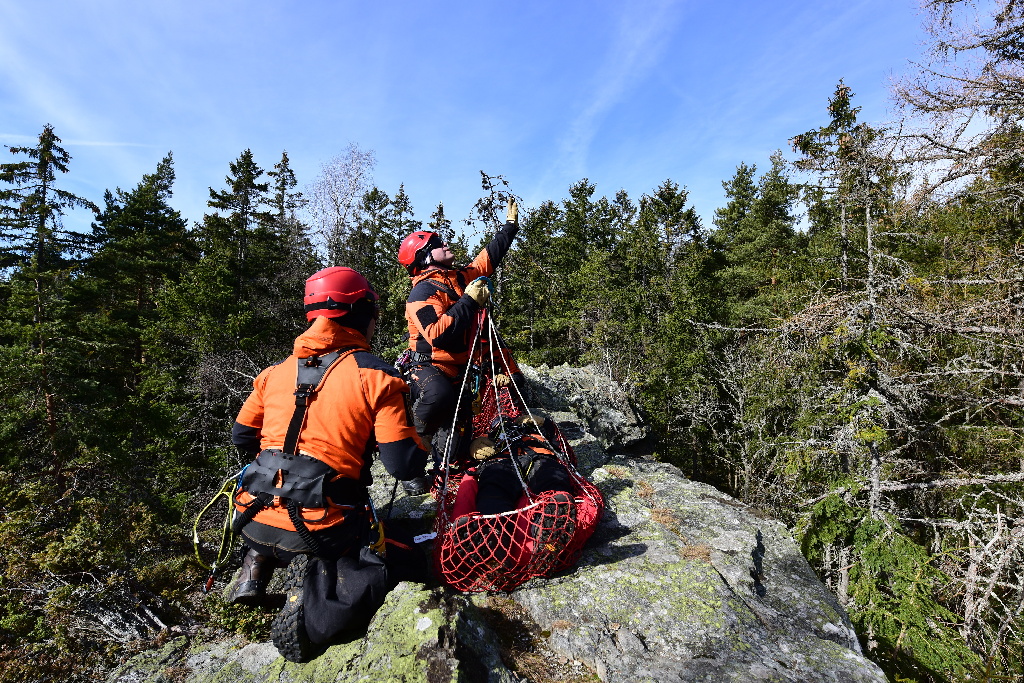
[0,0,922,239]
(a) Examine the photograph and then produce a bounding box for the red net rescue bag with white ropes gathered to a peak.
[433,309,604,592]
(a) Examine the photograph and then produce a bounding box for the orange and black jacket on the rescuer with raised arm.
[406,223,519,378]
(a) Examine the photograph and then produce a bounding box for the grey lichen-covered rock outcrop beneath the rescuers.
[110,367,886,683]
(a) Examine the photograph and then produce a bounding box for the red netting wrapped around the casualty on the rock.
[434,348,604,592]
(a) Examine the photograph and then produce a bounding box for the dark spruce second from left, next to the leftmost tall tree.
[75,153,193,479]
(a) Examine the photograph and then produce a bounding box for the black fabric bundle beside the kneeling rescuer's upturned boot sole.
[302,547,391,644]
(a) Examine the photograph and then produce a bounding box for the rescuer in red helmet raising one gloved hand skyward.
[398,199,519,495]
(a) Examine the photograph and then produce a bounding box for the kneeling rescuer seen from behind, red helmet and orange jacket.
[228,267,427,604]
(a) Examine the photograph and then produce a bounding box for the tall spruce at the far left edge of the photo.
[0,124,96,487]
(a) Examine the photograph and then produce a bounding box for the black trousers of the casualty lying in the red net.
[476,455,572,515]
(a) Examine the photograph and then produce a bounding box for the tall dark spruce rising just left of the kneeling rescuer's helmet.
[146,150,301,481]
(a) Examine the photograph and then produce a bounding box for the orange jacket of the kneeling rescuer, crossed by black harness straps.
[236,317,427,530]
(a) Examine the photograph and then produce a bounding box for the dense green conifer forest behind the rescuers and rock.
[0,0,1024,683]
